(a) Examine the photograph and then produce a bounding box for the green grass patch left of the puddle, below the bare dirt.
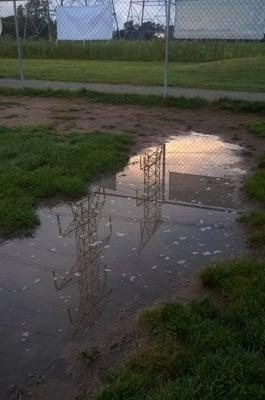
[0,126,131,236]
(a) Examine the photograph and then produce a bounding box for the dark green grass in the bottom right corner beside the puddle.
[97,259,265,400]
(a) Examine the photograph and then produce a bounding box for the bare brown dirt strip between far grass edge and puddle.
[0,97,264,150]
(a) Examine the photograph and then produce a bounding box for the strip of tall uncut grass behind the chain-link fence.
[0,39,265,62]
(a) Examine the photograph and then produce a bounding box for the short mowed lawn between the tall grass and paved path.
[0,56,265,91]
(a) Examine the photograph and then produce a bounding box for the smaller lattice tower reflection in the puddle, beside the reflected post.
[136,146,165,253]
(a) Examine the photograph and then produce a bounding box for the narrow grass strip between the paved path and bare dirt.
[0,87,265,115]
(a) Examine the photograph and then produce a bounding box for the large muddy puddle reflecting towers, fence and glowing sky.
[0,133,248,399]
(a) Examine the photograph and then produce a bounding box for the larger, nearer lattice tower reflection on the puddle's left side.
[55,188,112,337]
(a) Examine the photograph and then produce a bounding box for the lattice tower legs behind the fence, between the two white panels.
[127,0,167,25]
